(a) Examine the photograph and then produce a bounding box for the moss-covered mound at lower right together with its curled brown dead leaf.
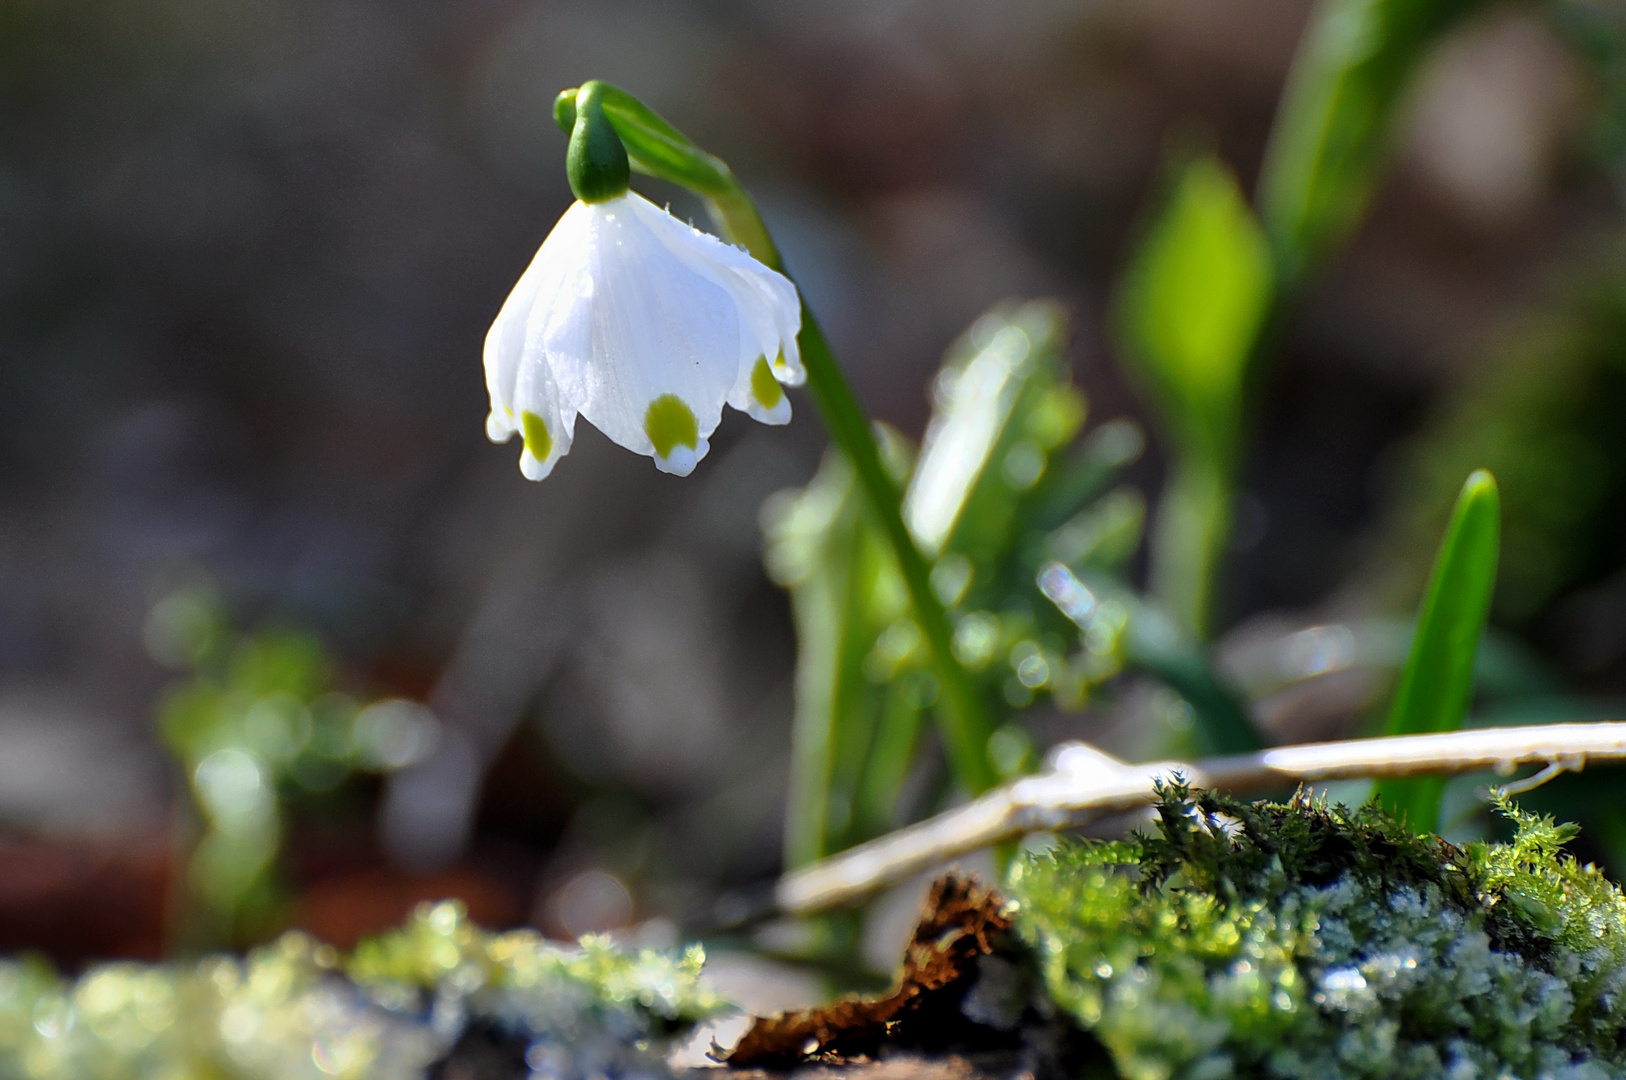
[735,786,1626,1080]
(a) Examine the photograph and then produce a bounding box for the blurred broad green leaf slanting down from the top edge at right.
[1260,0,1486,281]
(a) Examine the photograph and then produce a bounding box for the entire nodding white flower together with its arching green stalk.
[486,80,995,794]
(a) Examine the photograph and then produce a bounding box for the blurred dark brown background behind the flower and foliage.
[0,0,1626,961]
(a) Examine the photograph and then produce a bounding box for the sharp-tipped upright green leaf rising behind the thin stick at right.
[1377,468,1501,831]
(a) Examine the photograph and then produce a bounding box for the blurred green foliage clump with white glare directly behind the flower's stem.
[764,303,1141,864]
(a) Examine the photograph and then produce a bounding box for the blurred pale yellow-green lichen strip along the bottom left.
[0,903,720,1080]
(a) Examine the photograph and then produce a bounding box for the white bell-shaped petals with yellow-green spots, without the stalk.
[486,192,805,480]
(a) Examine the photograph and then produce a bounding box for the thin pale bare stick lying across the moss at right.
[774,721,1626,914]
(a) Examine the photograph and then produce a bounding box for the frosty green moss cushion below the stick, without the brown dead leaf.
[1010,786,1626,1080]
